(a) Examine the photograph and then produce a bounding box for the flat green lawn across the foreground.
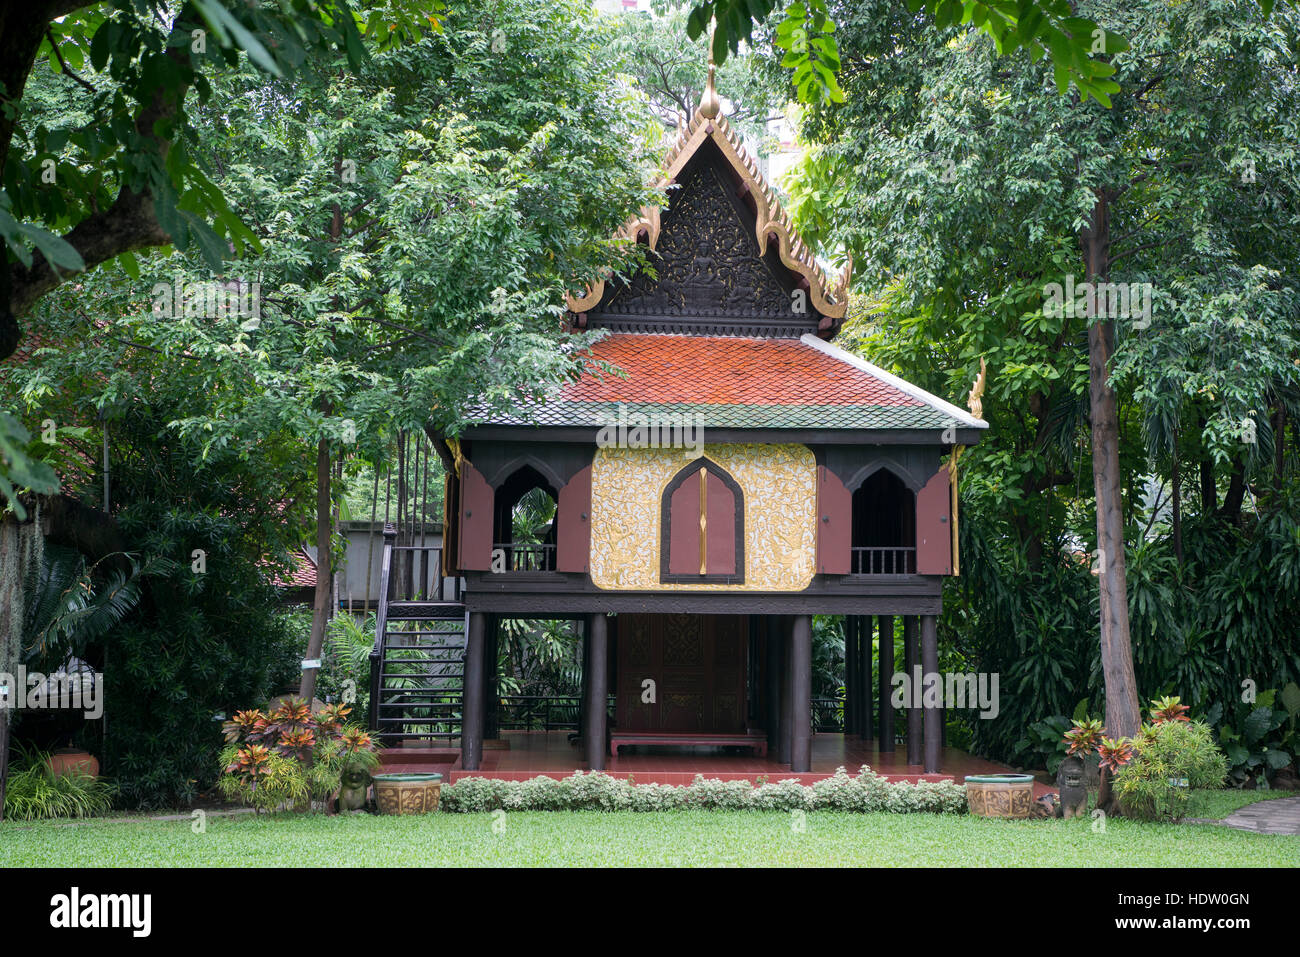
[0,792,1300,867]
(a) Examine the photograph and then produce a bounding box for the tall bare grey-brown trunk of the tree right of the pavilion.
[1080,191,1141,737]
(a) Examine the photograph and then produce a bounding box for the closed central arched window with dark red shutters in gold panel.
[659,459,745,584]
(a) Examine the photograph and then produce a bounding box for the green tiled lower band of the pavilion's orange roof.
[480,399,953,429]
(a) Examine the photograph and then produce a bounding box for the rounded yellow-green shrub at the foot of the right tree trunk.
[1114,720,1227,820]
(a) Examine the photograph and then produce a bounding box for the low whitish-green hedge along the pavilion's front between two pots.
[442,766,966,814]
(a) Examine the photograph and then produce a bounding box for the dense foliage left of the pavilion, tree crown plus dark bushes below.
[4,0,658,805]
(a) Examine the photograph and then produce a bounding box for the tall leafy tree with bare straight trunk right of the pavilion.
[797,1,1300,735]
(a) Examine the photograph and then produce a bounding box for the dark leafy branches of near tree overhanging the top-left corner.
[0,0,441,358]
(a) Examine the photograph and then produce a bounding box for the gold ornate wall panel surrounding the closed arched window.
[592,445,816,592]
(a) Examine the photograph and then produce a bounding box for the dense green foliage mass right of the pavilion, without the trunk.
[790,0,1300,763]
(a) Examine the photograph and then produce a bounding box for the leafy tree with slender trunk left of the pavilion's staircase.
[5,0,653,712]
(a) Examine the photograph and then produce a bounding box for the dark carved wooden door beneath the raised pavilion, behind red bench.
[616,615,749,733]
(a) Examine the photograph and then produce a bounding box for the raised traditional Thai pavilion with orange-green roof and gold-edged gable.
[371,70,987,772]
